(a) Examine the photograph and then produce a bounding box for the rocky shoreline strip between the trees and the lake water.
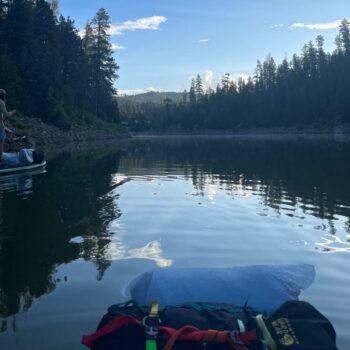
[5,117,350,160]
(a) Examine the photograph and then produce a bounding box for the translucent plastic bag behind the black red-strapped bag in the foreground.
[123,264,315,313]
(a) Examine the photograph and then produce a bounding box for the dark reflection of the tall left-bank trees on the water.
[0,150,120,318]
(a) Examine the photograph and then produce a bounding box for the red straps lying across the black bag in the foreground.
[82,316,256,349]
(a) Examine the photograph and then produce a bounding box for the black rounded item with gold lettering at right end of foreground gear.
[265,301,337,350]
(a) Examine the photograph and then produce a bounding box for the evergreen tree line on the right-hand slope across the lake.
[123,20,350,131]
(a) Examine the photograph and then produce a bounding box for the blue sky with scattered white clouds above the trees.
[59,0,350,94]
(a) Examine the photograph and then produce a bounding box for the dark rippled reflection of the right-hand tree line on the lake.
[120,138,350,220]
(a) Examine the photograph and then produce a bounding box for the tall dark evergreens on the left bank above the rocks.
[0,0,119,128]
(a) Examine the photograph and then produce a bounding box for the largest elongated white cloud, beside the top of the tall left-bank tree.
[108,16,167,35]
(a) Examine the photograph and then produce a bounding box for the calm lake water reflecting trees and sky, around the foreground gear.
[0,137,350,350]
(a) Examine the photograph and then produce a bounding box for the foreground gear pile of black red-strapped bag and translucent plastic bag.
[82,265,337,350]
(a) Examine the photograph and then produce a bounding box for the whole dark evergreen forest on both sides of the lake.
[0,0,350,132]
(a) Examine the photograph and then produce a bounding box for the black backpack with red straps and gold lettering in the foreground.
[82,301,336,350]
